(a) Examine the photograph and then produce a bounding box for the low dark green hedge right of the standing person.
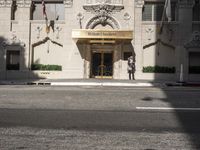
[142,66,175,73]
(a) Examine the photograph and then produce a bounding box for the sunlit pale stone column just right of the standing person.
[134,0,144,79]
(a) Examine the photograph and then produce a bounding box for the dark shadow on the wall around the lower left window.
[0,36,39,80]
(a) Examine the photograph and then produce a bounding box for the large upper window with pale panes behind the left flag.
[32,1,65,20]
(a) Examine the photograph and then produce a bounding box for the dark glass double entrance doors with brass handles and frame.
[91,52,113,78]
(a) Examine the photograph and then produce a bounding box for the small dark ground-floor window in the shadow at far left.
[6,51,20,70]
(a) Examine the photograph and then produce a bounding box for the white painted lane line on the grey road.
[136,107,200,111]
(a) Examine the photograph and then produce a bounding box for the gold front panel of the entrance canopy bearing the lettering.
[72,29,133,40]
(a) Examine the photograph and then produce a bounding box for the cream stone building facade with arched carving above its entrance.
[0,0,200,81]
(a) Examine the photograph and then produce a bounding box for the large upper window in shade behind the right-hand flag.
[142,2,176,21]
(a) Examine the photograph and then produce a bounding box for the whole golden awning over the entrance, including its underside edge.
[72,29,133,43]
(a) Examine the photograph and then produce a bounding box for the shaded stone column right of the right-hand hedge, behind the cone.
[175,0,193,81]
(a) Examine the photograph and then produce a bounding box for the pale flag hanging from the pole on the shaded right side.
[159,0,172,34]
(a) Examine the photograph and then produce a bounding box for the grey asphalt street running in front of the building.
[0,85,200,150]
